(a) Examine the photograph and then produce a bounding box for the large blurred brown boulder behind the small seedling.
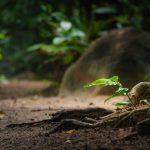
[59,28,150,96]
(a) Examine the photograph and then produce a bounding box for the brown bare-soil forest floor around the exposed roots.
[0,81,150,150]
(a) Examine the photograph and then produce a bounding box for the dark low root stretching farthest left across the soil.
[7,108,113,128]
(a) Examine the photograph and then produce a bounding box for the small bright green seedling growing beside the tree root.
[84,76,134,107]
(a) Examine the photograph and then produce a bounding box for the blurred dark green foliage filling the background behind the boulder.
[0,0,150,79]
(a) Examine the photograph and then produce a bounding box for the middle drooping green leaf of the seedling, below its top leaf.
[105,87,128,102]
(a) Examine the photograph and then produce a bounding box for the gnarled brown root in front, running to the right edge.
[49,107,150,133]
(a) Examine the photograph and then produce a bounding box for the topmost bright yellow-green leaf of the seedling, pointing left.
[84,76,121,87]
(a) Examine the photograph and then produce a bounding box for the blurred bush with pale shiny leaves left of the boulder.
[27,21,87,64]
